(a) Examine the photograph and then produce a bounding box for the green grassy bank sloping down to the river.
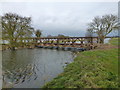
[44,39,118,88]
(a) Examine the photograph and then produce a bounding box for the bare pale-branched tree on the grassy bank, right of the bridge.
[88,14,120,43]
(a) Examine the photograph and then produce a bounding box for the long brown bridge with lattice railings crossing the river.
[23,37,114,51]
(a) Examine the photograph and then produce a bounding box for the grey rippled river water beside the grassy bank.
[2,49,74,88]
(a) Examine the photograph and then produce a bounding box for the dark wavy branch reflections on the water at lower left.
[3,64,38,88]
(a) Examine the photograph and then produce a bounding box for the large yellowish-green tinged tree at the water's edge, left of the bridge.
[1,13,34,49]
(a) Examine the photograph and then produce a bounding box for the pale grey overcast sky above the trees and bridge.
[0,2,118,36]
